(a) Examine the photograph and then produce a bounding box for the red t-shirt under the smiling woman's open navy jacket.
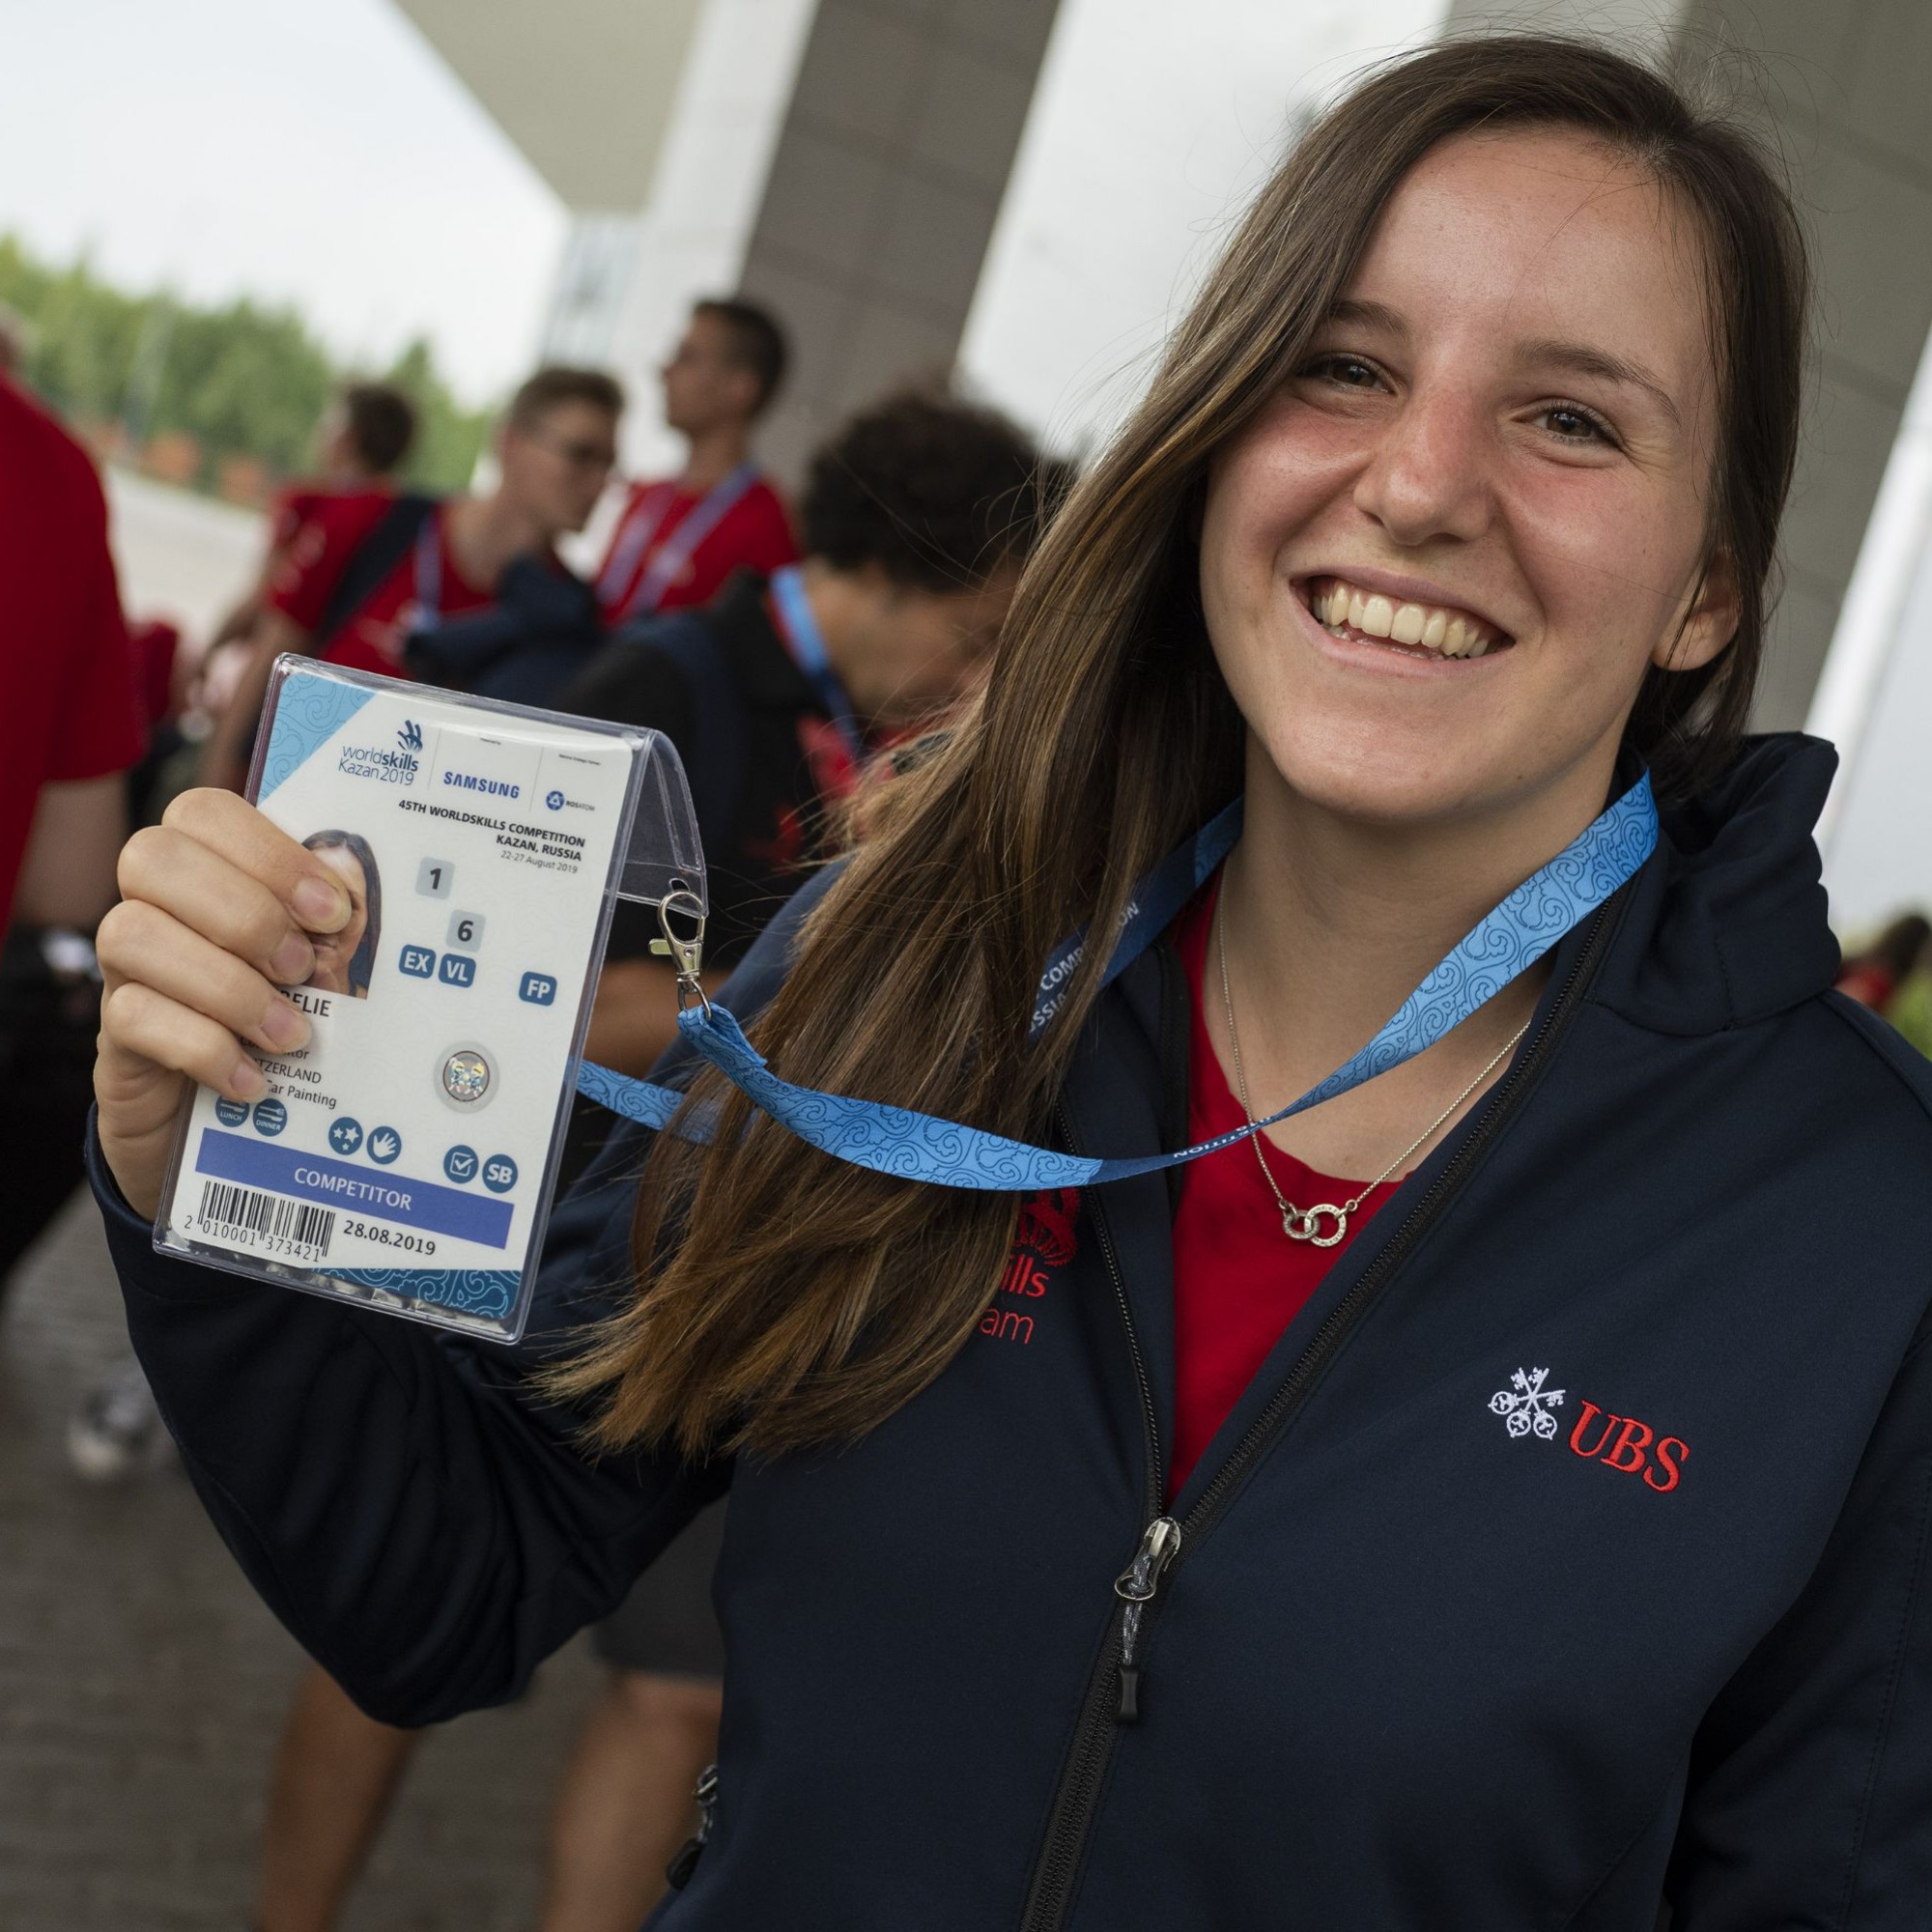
[1167,875,1397,1497]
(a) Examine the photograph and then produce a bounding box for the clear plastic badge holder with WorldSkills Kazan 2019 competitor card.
[155,657,707,1343]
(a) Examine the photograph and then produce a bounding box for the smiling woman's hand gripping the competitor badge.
[95,790,350,1215]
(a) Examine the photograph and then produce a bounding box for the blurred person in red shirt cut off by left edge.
[0,369,145,1287]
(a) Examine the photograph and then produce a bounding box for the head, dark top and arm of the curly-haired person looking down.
[572,390,1059,1074]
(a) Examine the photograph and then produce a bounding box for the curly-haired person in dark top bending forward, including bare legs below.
[259,394,1059,1932]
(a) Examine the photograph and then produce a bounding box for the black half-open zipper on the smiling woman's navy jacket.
[1020,893,1625,1932]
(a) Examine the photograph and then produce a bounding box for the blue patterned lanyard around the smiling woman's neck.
[578,773,1658,1194]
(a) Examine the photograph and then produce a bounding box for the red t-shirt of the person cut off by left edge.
[0,377,145,927]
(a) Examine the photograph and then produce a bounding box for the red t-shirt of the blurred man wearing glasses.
[269,489,495,676]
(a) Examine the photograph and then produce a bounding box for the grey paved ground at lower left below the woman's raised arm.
[0,1202,595,1932]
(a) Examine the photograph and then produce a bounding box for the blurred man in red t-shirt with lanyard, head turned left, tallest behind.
[597,299,798,624]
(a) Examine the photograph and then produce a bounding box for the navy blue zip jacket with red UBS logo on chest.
[97,738,1932,1932]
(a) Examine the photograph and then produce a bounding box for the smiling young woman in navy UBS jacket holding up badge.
[97,37,1932,1932]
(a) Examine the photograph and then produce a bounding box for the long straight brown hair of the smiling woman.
[556,35,1806,1455]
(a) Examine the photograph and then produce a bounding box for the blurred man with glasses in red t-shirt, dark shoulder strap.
[203,367,624,790]
